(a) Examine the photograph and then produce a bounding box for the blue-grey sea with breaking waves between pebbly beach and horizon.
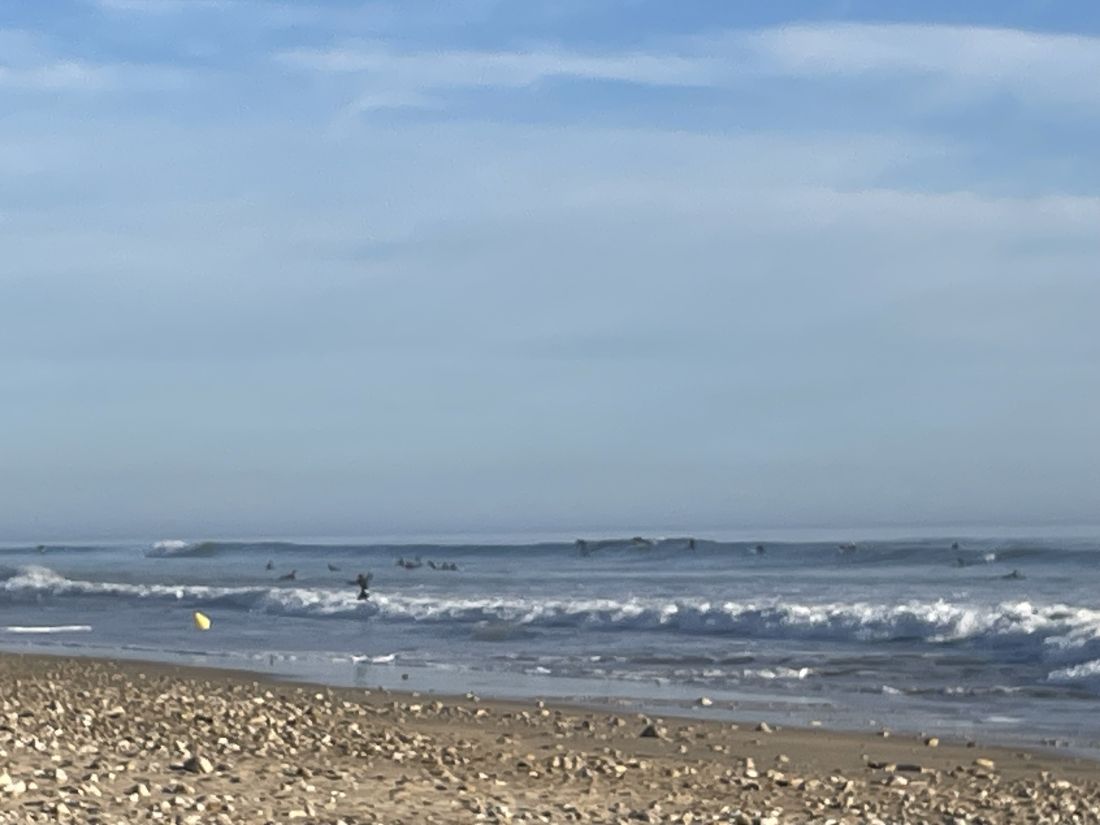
[0,538,1100,755]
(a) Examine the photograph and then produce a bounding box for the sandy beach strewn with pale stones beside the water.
[0,653,1100,825]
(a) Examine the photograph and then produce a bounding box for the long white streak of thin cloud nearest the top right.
[276,24,1100,113]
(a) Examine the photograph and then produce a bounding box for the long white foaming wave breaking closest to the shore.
[0,567,1100,664]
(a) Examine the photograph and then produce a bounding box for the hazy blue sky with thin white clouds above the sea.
[0,0,1100,540]
